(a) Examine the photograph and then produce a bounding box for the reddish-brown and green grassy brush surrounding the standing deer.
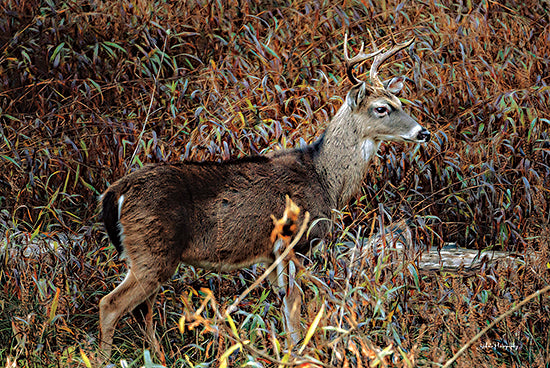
[0,0,550,368]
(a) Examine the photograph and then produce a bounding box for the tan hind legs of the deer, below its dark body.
[99,268,165,358]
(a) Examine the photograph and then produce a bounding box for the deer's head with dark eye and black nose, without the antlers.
[346,77,430,143]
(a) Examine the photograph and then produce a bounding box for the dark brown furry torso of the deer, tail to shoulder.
[102,139,331,271]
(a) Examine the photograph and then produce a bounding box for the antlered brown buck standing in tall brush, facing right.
[99,34,430,359]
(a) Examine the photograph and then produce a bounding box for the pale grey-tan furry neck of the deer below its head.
[315,104,380,209]
